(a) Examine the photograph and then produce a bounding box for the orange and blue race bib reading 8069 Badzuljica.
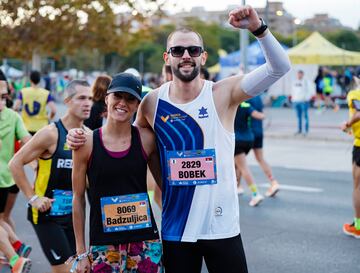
[100,193,151,232]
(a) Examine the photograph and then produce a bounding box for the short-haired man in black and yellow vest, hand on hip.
[9,80,92,273]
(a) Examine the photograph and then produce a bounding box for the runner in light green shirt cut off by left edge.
[0,70,31,272]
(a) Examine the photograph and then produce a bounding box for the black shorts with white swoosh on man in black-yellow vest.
[33,217,76,265]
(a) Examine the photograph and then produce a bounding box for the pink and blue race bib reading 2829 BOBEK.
[167,149,217,186]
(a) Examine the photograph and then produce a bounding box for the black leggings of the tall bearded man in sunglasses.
[163,234,248,273]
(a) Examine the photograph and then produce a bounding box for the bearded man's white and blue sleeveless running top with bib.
[153,81,240,242]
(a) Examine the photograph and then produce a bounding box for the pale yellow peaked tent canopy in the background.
[288,32,360,65]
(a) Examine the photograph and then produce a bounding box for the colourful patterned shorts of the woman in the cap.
[90,240,163,273]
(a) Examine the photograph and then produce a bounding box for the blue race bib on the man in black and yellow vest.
[50,190,72,216]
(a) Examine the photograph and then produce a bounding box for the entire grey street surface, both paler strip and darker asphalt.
[9,105,360,273]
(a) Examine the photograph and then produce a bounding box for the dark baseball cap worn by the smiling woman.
[107,73,142,100]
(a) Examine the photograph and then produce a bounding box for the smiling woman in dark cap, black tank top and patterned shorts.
[73,73,162,273]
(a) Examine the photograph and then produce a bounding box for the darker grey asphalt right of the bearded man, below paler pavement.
[240,168,360,273]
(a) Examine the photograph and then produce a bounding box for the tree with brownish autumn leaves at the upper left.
[0,0,160,69]
